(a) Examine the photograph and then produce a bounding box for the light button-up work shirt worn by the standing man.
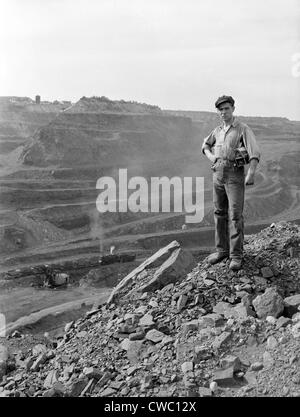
[202,117,260,161]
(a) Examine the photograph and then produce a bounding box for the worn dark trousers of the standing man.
[212,160,245,259]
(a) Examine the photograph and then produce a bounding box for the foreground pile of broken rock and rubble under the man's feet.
[0,223,300,397]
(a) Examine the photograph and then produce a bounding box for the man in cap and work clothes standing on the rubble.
[202,96,260,271]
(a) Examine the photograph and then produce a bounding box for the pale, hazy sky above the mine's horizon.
[0,0,300,120]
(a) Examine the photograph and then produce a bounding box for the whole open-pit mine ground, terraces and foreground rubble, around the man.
[0,97,300,396]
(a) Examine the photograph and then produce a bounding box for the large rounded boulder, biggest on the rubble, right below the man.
[252,287,284,319]
